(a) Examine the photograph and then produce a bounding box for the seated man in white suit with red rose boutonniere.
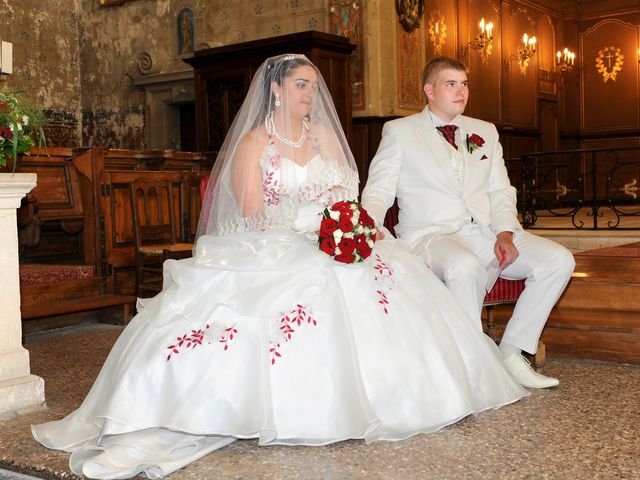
[362,57,575,388]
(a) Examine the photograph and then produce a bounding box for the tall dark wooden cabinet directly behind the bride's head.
[185,31,356,152]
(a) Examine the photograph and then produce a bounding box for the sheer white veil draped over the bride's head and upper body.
[197,54,358,238]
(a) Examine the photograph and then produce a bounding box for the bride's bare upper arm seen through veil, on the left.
[231,132,265,217]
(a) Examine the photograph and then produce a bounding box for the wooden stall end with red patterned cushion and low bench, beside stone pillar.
[18,147,136,333]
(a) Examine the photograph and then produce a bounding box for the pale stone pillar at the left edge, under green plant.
[0,173,44,417]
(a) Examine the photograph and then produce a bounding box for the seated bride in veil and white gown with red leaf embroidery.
[32,55,528,478]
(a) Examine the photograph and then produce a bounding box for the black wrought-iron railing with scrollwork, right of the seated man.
[508,147,640,230]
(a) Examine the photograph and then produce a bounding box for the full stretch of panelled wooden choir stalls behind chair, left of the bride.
[18,147,212,332]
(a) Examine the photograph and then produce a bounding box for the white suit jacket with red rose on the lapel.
[362,107,522,246]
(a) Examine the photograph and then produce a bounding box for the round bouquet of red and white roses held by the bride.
[318,200,376,263]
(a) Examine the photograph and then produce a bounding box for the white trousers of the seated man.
[424,223,575,354]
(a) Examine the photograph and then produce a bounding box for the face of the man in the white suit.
[424,68,469,122]
